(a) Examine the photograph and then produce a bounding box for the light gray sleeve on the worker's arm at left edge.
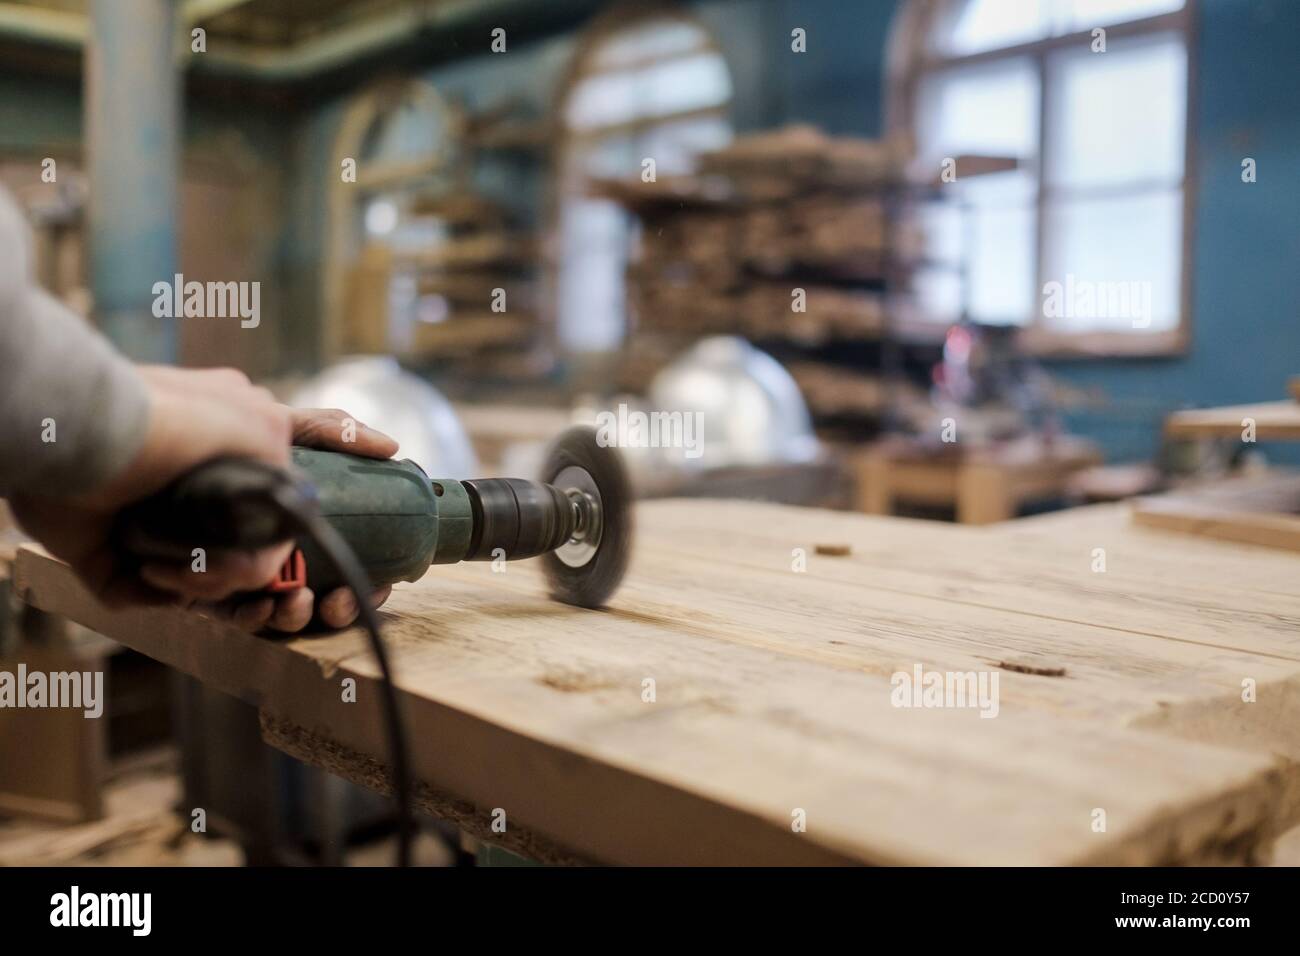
[0,189,150,496]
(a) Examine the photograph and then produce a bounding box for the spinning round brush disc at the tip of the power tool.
[541,427,632,607]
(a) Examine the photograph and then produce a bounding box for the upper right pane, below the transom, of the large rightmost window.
[1045,35,1187,186]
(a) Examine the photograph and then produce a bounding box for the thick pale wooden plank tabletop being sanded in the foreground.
[16,501,1300,864]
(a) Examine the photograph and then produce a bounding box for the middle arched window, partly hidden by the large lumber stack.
[555,8,732,352]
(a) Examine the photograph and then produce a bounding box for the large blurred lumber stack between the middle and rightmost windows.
[592,126,917,421]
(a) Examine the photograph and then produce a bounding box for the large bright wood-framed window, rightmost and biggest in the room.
[889,0,1193,354]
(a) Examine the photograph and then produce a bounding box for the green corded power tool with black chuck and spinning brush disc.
[114,427,632,865]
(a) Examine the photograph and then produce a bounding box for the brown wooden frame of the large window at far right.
[887,0,1199,359]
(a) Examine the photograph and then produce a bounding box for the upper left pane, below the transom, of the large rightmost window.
[917,60,1039,164]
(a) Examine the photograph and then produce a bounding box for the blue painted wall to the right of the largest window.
[1054,0,1300,462]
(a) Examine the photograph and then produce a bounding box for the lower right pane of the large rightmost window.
[1039,189,1183,332]
